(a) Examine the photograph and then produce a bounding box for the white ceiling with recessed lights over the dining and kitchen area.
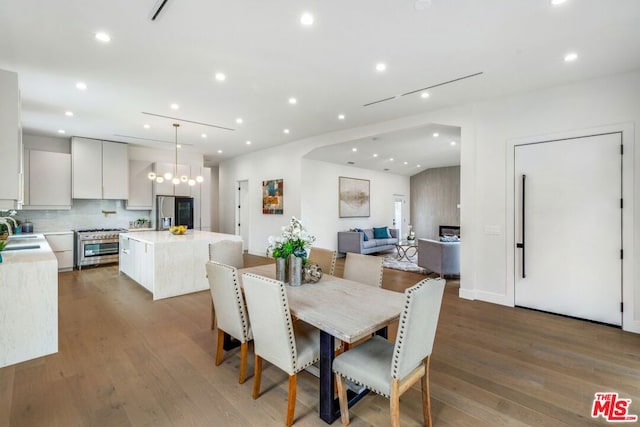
[0,0,640,169]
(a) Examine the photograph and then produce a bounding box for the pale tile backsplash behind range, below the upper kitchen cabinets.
[16,199,151,233]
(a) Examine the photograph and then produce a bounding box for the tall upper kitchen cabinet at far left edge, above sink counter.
[0,70,23,209]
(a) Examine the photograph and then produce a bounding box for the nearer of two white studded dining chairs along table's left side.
[242,273,340,426]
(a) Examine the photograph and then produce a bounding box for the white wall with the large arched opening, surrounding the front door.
[220,71,640,332]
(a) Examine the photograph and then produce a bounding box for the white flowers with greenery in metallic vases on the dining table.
[267,217,316,286]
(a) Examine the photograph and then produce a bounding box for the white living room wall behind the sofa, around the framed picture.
[301,159,409,249]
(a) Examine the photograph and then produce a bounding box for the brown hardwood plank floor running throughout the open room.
[0,256,640,427]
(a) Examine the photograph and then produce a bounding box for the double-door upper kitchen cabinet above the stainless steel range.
[71,137,129,200]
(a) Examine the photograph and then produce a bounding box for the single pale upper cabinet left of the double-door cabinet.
[23,150,71,209]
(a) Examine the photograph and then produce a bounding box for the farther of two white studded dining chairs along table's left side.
[206,261,252,384]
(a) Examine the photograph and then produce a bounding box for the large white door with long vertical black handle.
[514,132,623,325]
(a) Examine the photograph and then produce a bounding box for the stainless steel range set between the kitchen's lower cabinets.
[74,228,127,270]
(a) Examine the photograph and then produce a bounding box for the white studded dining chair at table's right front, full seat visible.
[333,279,445,427]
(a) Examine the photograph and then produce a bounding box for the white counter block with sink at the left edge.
[0,234,58,368]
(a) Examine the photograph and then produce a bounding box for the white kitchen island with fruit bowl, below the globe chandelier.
[119,230,241,300]
